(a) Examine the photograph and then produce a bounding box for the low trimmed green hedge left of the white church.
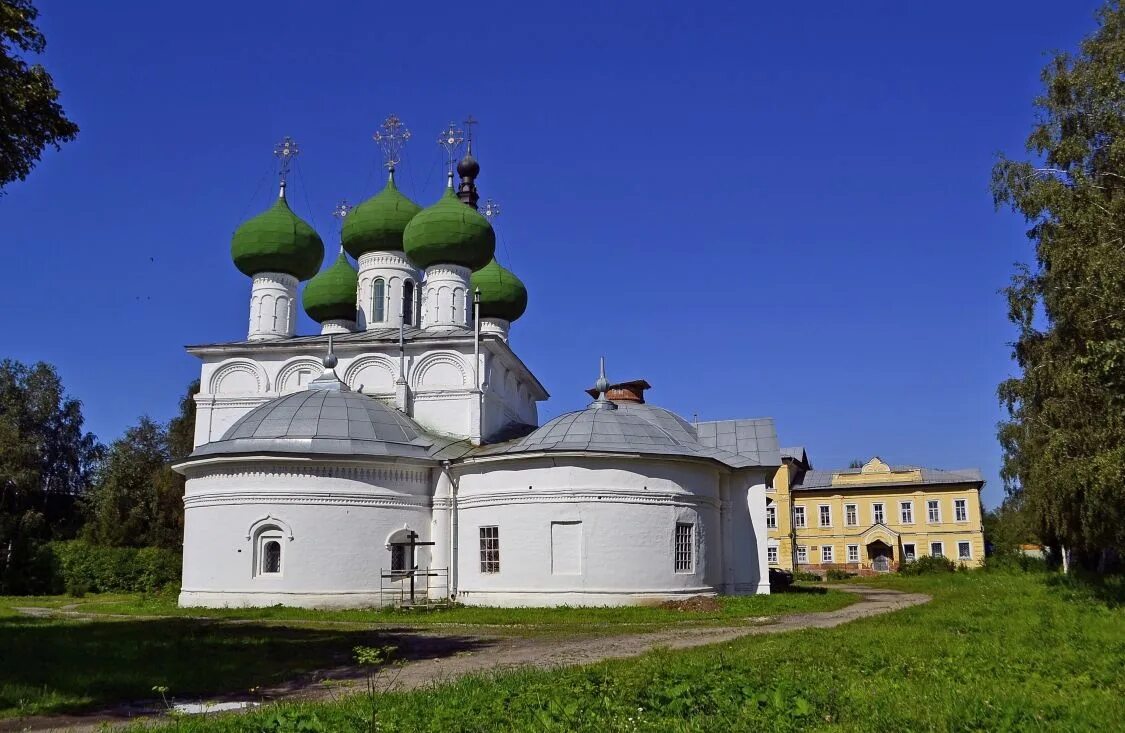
[39,540,180,596]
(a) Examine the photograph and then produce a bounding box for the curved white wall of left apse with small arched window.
[180,461,433,607]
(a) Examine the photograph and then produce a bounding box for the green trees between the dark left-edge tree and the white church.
[83,381,199,549]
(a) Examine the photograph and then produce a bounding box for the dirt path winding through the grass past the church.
[0,586,930,732]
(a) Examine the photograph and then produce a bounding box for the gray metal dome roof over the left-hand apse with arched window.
[191,389,437,458]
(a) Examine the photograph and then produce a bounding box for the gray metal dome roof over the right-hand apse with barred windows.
[475,401,758,468]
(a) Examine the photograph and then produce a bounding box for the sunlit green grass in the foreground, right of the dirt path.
[129,571,1125,732]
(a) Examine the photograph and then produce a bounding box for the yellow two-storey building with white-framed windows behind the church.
[766,447,984,572]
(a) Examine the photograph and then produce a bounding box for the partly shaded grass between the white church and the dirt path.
[0,591,853,718]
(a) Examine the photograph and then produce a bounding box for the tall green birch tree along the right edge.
[992,0,1125,558]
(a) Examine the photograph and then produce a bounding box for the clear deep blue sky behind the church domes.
[0,0,1098,505]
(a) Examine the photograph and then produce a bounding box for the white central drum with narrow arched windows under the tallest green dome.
[356,252,422,331]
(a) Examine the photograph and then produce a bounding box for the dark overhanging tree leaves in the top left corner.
[0,0,78,189]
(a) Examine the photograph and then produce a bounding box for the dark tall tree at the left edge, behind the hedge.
[0,360,102,594]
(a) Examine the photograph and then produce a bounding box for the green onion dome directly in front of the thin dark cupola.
[403,177,496,270]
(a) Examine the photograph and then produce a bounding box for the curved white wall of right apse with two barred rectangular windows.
[453,456,742,606]
